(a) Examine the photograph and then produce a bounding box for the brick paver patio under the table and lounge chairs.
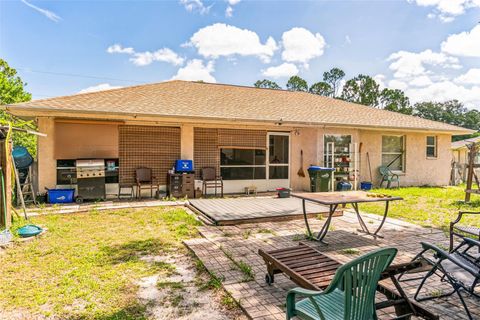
[185,211,480,319]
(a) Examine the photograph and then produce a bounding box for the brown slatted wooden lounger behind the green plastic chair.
[258,242,439,320]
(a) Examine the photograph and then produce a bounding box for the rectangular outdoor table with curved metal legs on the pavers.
[292,191,403,242]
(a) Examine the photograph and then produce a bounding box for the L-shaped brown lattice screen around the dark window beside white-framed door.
[193,128,267,179]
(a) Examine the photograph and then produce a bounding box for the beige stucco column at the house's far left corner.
[37,117,56,192]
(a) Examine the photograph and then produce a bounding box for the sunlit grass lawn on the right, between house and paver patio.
[360,186,480,229]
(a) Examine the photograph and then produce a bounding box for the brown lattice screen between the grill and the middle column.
[119,126,180,184]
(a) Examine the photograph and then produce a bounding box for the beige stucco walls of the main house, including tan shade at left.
[33,117,452,194]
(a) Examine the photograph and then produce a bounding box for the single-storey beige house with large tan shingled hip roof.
[6,80,471,194]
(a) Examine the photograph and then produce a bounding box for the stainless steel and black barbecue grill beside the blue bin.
[75,159,105,203]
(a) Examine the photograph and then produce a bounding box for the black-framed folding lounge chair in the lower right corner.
[402,238,480,320]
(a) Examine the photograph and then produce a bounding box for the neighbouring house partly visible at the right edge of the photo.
[451,137,480,185]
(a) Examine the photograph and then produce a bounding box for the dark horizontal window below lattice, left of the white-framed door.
[220,148,266,180]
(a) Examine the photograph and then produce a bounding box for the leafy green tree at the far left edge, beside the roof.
[0,59,37,157]
